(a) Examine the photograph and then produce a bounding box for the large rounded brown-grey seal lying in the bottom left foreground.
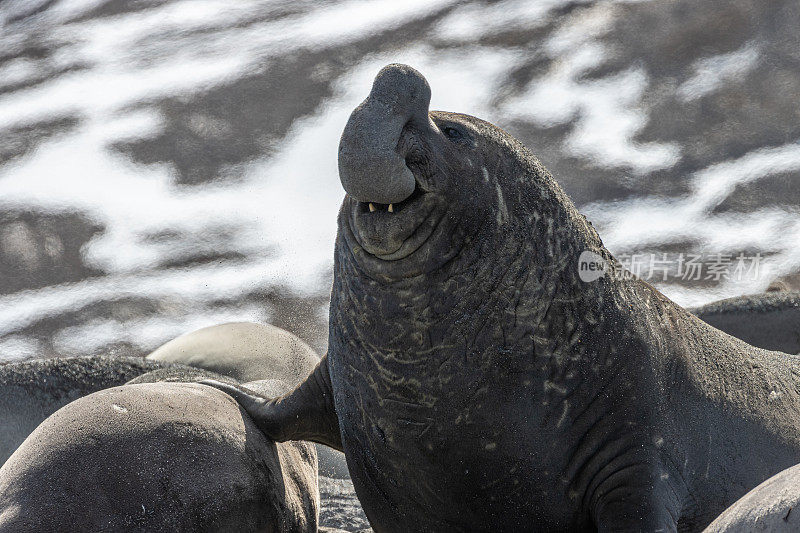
[0,383,319,533]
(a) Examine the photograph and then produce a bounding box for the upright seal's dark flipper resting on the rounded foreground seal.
[199,355,343,451]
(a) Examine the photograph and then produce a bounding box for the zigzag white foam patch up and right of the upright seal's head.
[503,5,680,175]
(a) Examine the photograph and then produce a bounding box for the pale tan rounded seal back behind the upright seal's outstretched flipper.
[147,322,349,478]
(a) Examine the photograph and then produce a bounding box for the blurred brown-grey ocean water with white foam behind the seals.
[0,0,800,360]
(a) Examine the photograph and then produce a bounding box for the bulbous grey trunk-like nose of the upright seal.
[339,64,431,204]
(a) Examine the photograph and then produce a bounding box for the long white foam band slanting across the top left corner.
[0,0,454,126]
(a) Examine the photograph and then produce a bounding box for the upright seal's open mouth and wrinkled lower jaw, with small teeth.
[350,179,440,261]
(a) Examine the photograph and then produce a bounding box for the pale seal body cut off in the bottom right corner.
[705,465,800,533]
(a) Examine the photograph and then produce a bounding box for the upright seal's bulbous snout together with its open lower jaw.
[339,65,444,261]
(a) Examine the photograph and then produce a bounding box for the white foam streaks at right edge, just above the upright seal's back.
[583,142,800,305]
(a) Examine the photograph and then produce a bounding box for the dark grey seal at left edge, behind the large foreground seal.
[0,356,165,464]
